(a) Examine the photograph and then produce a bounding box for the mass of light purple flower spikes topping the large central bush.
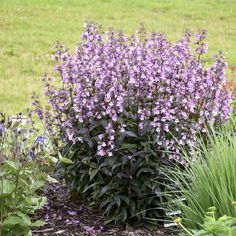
[34,23,231,161]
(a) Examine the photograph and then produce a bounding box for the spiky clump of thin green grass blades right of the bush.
[165,126,236,229]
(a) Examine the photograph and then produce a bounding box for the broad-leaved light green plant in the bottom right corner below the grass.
[175,205,236,236]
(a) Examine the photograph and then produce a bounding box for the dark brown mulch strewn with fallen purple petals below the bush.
[32,184,177,236]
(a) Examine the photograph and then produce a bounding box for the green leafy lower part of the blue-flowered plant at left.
[0,160,46,236]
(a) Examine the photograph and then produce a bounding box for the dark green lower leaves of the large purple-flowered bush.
[59,114,168,223]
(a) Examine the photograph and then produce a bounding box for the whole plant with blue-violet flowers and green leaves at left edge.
[0,114,50,236]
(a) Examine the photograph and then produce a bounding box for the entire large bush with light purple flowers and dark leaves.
[34,23,231,222]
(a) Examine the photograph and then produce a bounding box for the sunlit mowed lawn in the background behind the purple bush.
[0,0,236,114]
